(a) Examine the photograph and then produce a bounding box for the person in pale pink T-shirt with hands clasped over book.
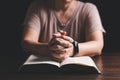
[22,0,105,61]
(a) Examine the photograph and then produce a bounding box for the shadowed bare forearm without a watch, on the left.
[22,40,49,56]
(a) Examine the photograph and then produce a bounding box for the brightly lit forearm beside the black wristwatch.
[76,41,103,56]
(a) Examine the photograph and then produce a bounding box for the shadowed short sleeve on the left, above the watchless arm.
[23,1,40,32]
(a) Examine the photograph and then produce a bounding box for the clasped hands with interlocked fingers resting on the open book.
[49,30,73,62]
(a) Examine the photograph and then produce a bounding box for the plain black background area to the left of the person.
[0,0,32,72]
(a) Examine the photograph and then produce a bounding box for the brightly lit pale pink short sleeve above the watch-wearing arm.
[84,3,106,37]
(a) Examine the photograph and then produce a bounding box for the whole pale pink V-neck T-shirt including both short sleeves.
[24,0,105,42]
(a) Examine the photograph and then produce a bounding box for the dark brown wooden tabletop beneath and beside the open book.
[0,53,120,80]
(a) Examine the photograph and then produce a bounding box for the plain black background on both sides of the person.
[0,0,120,72]
